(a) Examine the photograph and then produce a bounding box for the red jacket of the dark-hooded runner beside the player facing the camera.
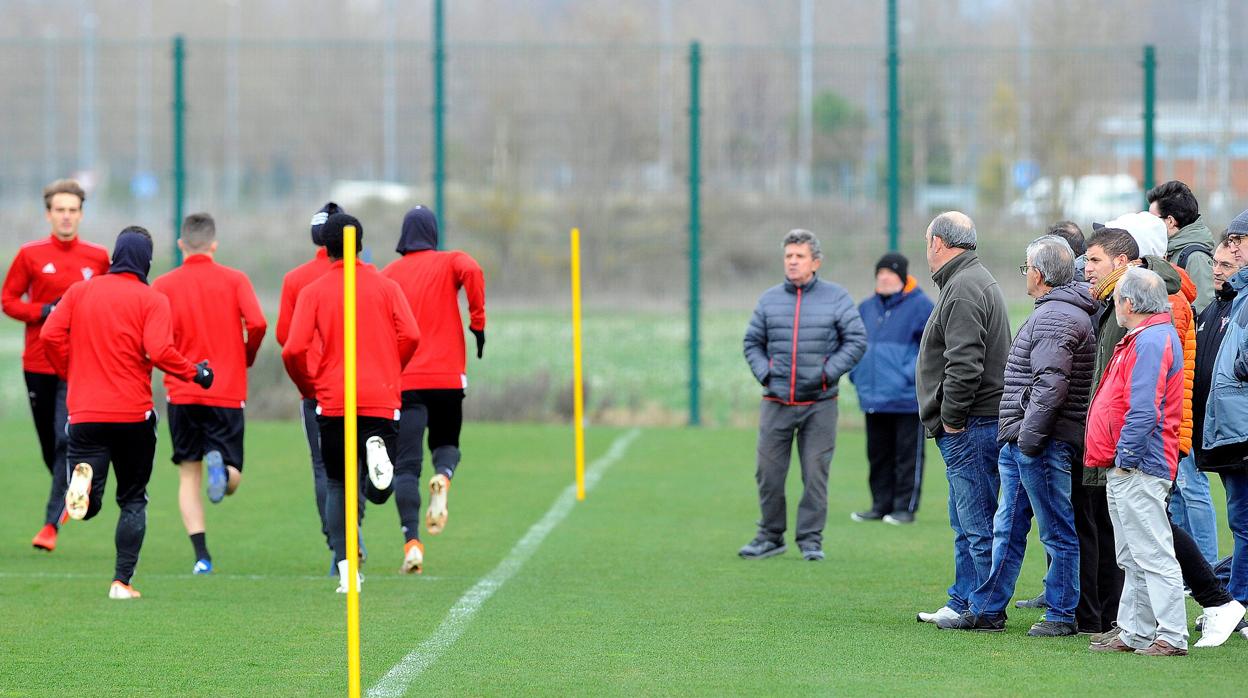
[40,273,199,425]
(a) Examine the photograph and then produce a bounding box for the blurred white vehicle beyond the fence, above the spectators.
[1007,175,1144,230]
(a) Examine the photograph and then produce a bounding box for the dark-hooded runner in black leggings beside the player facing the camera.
[40,226,212,599]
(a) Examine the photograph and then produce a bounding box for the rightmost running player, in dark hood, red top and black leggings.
[382,206,485,537]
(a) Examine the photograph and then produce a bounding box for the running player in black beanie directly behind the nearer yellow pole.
[282,212,424,593]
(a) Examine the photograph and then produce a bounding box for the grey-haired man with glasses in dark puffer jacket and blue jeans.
[936,235,1098,637]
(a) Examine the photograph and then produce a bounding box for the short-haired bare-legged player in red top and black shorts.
[152,214,267,574]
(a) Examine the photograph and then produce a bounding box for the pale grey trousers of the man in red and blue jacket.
[1106,468,1187,649]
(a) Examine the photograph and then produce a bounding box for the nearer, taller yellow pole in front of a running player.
[342,226,359,698]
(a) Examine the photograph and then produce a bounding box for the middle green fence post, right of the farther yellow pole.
[689,41,701,427]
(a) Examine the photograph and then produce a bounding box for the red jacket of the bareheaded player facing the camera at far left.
[4,235,109,375]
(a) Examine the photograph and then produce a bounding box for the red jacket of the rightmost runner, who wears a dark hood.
[382,250,485,390]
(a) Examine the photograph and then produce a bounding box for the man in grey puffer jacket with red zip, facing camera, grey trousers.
[739,230,866,561]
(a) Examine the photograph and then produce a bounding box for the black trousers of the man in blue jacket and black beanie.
[866,413,926,513]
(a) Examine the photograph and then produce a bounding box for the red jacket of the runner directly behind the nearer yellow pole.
[282,260,421,420]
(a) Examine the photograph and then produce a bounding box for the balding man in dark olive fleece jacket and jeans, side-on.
[915,211,1010,623]
